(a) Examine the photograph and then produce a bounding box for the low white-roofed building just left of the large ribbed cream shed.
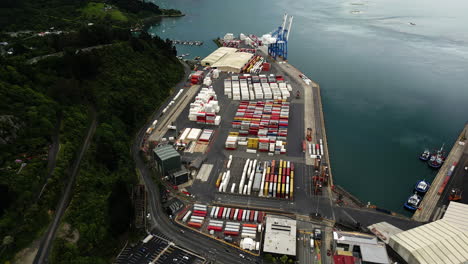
[333,231,390,264]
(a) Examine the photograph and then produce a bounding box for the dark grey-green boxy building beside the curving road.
[153,145,181,176]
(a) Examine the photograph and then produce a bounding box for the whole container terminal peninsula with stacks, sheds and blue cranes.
[132,16,454,263]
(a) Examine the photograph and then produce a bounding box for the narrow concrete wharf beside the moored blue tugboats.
[413,124,468,222]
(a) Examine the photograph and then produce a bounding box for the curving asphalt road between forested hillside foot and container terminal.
[131,61,264,263]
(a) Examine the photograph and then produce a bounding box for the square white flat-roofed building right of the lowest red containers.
[263,215,296,256]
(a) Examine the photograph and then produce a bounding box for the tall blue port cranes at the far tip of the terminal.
[262,14,294,60]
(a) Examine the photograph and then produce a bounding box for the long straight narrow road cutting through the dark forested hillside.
[33,110,97,264]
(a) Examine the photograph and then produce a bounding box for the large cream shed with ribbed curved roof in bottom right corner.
[389,202,468,264]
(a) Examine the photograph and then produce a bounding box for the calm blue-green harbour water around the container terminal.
[149,0,468,212]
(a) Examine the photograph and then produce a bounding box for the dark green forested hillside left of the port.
[0,0,183,263]
